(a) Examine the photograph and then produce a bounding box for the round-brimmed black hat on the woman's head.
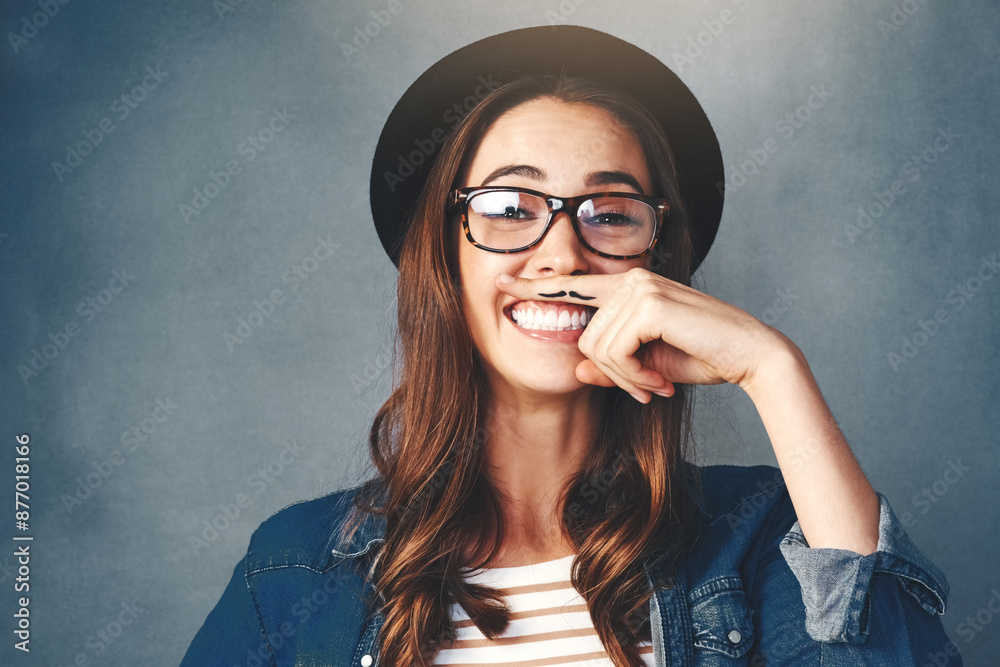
[369,25,725,270]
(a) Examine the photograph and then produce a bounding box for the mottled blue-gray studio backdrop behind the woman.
[0,0,1000,666]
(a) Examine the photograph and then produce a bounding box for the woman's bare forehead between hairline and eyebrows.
[466,98,653,195]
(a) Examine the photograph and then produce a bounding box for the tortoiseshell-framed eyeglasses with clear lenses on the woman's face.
[449,187,670,259]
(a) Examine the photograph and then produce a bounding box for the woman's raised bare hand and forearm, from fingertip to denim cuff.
[495,268,879,555]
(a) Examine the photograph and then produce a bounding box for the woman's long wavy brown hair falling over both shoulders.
[355,76,695,667]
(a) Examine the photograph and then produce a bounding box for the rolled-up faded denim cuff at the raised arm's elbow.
[780,494,949,644]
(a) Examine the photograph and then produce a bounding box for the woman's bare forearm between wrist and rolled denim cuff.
[743,336,879,555]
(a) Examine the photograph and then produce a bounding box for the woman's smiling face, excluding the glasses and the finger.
[452,97,653,402]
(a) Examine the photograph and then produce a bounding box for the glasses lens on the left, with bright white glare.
[468,191,549,250]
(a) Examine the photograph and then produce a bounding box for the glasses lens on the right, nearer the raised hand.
[576,197,656,255]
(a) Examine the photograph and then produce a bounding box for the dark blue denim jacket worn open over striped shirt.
[181,466,962,667]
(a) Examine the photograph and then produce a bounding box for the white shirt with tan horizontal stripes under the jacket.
[434,555,653,667]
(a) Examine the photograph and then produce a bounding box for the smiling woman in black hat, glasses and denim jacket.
[184,26,961,667]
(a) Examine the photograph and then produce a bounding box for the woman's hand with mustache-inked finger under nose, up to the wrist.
[496,268,794,403]
